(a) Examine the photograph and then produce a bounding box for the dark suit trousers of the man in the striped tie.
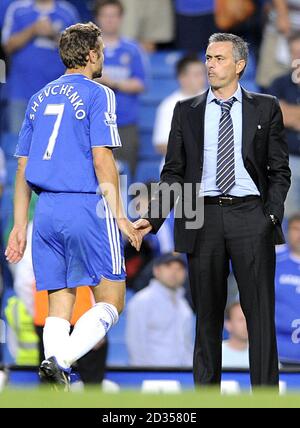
[188,198,279,386]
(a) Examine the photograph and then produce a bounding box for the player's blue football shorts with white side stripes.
[32,192,126,290]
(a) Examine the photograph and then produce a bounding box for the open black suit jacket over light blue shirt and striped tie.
[143,89,291,253]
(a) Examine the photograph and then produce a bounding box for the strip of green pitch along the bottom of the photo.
[0,389,300,408]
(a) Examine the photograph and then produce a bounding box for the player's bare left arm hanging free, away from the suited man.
[5,157,31,263]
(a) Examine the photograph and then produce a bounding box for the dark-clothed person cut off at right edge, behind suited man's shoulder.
[268,32,300,217]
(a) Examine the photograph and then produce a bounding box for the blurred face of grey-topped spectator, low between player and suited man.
[154,261,186,290]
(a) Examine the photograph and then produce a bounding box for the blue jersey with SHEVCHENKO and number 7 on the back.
[15,74,121,193]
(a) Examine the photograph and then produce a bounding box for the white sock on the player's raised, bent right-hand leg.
[63,303,119,367]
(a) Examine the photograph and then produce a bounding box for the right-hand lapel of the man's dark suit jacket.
[242,89,260,161]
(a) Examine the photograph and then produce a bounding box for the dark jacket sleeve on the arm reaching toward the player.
[143,102,186,233]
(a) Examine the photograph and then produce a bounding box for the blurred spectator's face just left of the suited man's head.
[178,62,206,96]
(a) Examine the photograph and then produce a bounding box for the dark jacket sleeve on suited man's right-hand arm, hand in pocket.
[266,97,291,222]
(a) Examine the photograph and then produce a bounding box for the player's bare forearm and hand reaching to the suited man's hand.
[93,147,141,251]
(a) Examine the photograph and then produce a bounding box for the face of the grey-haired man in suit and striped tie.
[206,42,245,89]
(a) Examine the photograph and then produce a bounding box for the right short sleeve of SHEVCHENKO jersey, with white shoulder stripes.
[90,86,122,149]
